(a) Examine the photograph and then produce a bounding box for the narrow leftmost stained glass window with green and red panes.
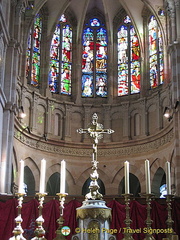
[26,13,42,87]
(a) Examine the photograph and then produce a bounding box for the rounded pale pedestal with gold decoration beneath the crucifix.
[72,200,116,240]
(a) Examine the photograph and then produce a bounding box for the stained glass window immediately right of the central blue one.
[117,16,140,96]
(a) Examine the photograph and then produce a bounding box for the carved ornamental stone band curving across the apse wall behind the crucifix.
[14,126,174,157]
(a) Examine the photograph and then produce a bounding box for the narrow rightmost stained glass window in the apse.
[148,16,164,88]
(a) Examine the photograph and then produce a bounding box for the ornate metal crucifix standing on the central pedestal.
[77,113,114,200]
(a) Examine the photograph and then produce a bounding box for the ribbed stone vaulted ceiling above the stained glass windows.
[31,0,163,49]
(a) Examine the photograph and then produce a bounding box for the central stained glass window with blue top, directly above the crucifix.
[82,18,107,97]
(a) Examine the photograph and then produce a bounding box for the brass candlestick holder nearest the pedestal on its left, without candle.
[54,193,68,240]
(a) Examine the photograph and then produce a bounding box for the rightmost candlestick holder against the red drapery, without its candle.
[166,194,174,240]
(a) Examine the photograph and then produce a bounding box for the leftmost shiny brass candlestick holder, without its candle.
[9,193,26,240]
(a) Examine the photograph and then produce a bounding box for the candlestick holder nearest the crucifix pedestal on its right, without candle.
[123,194,134,240]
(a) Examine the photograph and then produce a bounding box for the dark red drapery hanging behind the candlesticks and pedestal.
[0,198,180,240]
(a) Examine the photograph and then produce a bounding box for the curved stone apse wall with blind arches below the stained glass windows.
[13,79,174,195]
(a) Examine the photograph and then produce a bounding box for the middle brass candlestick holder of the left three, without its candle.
[32,193,47,240]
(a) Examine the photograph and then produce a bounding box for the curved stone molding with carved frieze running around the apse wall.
[14,124,174,157]
